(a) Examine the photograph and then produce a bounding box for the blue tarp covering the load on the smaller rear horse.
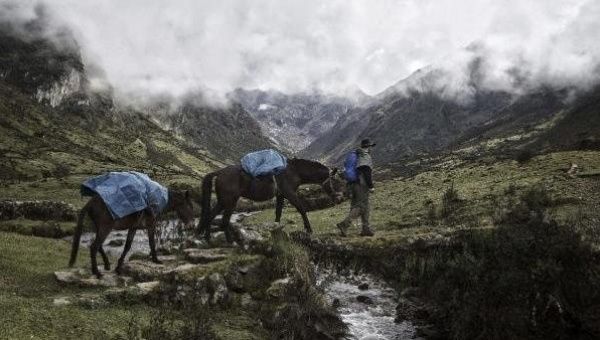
[81,171,169,219]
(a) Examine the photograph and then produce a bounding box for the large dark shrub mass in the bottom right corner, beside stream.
[404,188,600,339]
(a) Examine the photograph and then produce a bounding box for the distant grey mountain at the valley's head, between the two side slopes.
[228,88,369,153]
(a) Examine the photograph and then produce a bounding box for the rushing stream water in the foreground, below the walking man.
[317,269,419,340]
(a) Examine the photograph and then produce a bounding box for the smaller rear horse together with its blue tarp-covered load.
[69,171,194,277]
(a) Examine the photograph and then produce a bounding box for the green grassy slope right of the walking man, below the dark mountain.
[247,151,600,244]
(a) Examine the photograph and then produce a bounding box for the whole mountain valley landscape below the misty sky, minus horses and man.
[0,7,600,340]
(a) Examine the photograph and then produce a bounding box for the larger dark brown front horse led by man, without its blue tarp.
[198,158,344,243]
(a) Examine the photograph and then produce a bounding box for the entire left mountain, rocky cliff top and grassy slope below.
[0,17,235,202]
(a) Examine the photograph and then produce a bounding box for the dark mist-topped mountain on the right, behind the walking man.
[302,68,600,164]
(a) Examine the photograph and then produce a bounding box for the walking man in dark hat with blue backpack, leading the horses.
[337,139,375,236]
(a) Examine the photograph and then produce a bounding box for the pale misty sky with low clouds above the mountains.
[0,0,600,99]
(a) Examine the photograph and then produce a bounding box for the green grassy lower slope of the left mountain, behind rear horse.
[0,84,222,206]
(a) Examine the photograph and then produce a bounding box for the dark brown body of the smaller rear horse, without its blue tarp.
[69,190,194,278]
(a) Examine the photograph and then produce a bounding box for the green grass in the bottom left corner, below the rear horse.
[0,233,159,339]
